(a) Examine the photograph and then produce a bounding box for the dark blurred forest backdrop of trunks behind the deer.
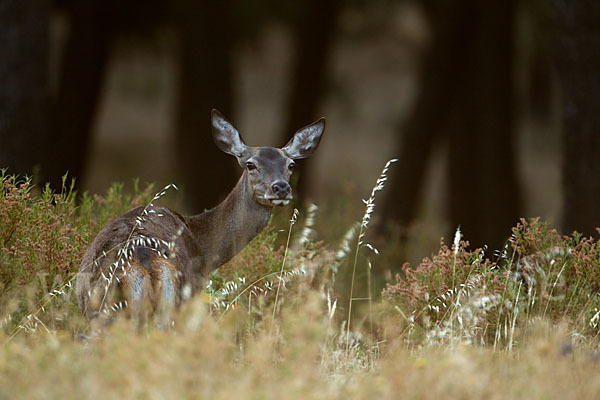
[0,0,600,268]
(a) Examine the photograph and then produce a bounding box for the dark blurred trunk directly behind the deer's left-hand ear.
[175,0,238,211]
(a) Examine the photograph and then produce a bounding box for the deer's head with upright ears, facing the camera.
[211,110,325,207]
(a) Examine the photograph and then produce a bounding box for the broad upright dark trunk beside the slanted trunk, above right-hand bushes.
[448,0,520,249]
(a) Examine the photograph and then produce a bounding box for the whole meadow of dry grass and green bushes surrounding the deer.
[0,164,600,399]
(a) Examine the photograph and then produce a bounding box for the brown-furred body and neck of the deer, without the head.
[76,173,272,320]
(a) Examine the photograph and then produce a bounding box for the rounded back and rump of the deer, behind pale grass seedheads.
[76,207,202,328]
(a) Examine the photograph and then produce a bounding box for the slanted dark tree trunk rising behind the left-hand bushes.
[43,0,116,190]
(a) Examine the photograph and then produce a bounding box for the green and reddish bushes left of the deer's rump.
[0,170,152,333]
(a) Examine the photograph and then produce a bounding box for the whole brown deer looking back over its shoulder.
[76,110,325,329]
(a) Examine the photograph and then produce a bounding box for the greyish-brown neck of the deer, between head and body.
[187,171,273,273]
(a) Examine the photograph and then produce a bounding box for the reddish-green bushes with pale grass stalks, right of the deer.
[382,219,600,349]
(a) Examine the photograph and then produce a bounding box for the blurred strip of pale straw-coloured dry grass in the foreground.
[0,302,600,399]
